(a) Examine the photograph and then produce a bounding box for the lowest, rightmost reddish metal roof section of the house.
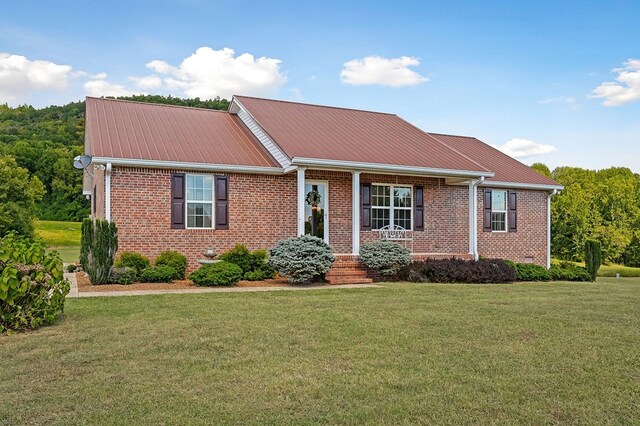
[429,133,559,185]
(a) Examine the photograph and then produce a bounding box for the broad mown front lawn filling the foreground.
[0,279,640,425]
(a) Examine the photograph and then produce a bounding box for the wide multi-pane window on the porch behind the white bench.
[371,185,413,229]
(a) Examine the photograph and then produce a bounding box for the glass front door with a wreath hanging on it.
[304,180,329,244]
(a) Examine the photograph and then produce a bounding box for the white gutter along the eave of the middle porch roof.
[291,157,494,178]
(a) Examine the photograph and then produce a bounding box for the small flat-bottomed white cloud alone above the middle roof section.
[340,56,429,87]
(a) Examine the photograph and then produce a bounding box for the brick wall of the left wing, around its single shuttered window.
[111,167,297,270]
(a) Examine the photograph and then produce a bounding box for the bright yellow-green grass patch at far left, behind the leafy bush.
[36,220,82,263]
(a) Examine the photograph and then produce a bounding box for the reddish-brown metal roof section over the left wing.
[86,97,280,167]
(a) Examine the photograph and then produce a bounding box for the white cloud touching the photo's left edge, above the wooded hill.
[0,52,73,104]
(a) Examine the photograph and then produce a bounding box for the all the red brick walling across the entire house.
[102,167,546,270]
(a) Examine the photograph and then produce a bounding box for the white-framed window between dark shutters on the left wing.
[186,175,213,228]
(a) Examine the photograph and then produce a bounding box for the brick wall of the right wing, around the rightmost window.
[478,188,547,266]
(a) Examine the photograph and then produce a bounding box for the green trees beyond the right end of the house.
[531,163,640,266]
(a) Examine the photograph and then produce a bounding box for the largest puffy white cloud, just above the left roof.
[132,47,287,99]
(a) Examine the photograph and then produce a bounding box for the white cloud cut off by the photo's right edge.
[590,59,640,106]
